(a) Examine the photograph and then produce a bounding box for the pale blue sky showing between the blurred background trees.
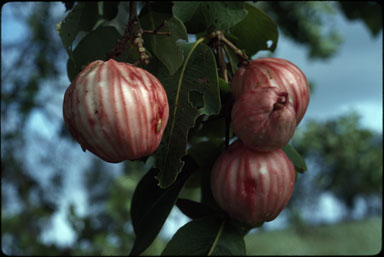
[1,3,383,246]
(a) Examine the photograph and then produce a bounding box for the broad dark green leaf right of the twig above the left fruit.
[140,3,188,75]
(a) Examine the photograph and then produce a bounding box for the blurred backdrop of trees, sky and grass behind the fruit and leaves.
[1,1,383,255]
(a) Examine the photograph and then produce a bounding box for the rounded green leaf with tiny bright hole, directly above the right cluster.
[231,4,279,57]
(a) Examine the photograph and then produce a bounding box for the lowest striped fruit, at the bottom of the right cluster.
[211,140,295,227]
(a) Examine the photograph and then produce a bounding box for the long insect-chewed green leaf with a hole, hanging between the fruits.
[152,40,220,188]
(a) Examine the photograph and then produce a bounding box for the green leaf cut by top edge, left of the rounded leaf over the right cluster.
[200,1,247,32]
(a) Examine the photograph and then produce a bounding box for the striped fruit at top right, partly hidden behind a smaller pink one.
[231,57,310,125]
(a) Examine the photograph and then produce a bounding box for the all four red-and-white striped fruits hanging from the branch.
[63,55,309,226]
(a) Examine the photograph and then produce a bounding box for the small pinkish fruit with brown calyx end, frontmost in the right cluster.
[232,87,296,151]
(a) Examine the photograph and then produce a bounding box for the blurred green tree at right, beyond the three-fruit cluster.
[293,113,383,218]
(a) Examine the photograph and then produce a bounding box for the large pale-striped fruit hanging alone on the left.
[63,59,169,163]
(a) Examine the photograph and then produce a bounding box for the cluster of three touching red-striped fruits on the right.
[211,58,309,226]
